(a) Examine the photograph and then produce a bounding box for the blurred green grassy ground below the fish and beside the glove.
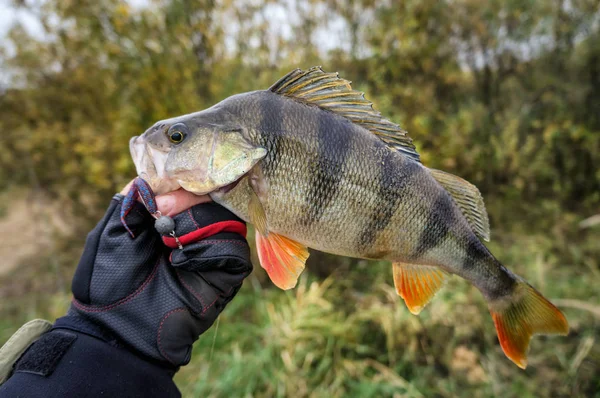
[0,197,600,397]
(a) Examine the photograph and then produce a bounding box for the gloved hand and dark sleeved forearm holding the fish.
[0,188,252,398]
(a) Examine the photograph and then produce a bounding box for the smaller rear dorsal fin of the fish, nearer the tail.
[429,169,490,242]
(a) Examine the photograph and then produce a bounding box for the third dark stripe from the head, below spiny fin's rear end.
[357,148,421,257]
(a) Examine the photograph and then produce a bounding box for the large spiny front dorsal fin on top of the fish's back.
[269,66,420,161]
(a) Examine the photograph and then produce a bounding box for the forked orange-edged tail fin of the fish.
[489,281,569,369]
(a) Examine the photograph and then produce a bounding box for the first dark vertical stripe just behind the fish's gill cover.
[258,95,284,177]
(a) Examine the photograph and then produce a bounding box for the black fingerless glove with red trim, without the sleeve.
[62,195,252,369]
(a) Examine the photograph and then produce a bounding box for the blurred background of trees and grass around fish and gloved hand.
[0,0,600,397]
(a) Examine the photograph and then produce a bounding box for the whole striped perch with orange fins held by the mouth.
[130,67,569,369]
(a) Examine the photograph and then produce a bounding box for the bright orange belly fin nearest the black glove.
[256,231,308,290]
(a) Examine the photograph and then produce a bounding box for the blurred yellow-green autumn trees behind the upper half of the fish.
[0,0,600,218]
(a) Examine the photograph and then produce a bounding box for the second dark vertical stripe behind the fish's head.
[301,111,352,226]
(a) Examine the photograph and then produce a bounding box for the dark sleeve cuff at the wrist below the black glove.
[0,327,181,397]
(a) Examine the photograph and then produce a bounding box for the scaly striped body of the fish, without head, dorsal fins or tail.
[211,91,513,296]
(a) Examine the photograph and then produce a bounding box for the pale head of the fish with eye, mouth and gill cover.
[129,113,267,195]
